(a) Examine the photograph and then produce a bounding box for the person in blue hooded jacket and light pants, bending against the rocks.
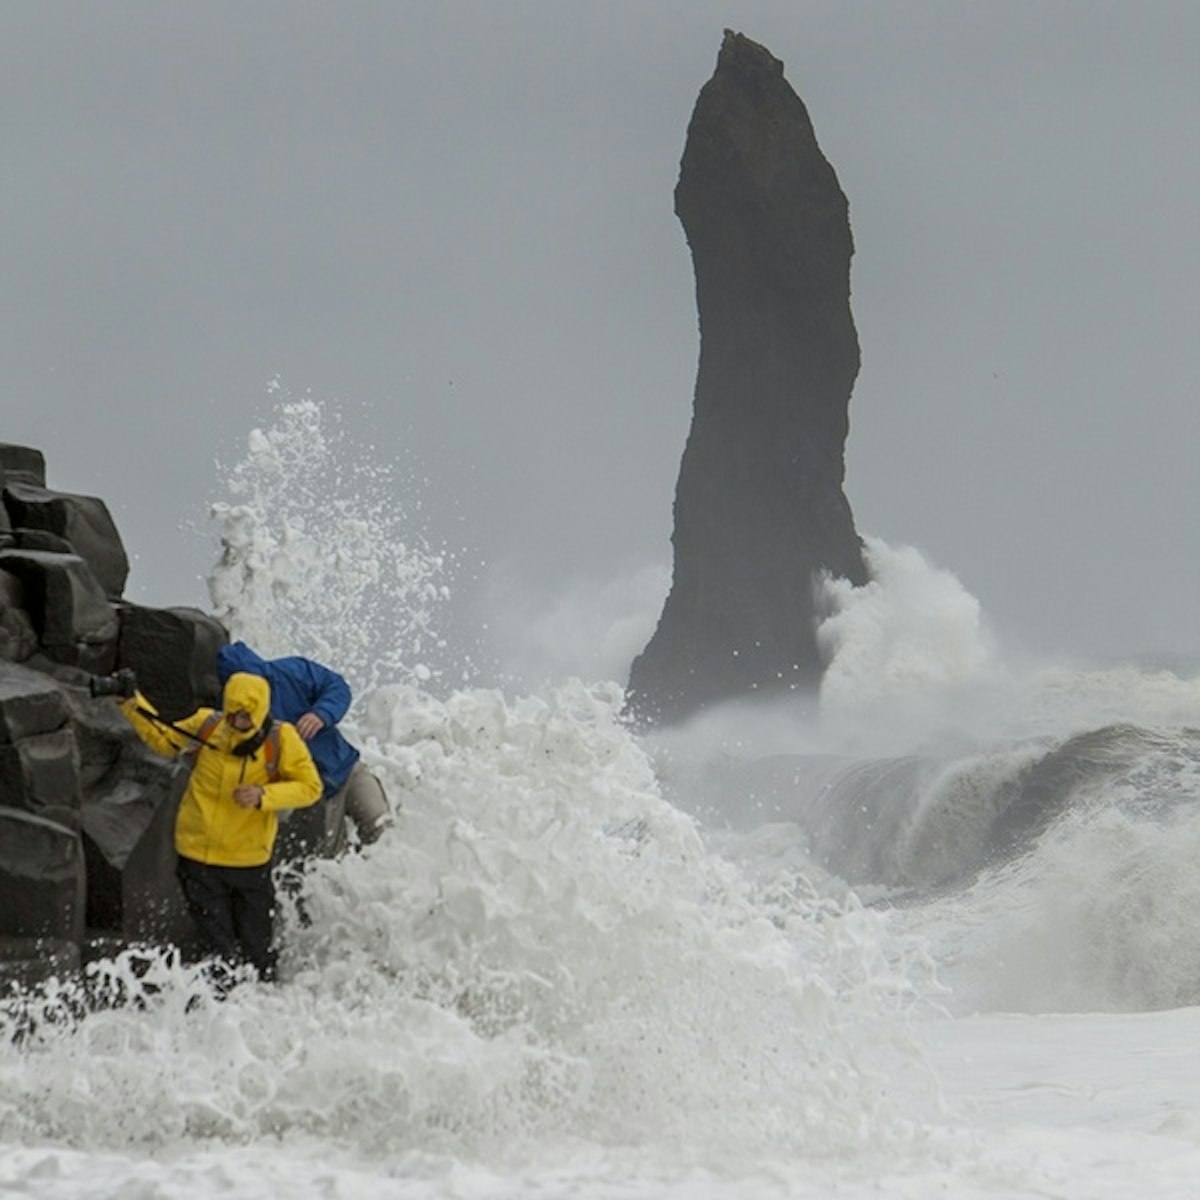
[217,642,389,859]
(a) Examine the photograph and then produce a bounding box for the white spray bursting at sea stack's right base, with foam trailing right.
[816,538,1200,755]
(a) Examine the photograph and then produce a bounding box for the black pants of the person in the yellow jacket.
[175,857,275,979]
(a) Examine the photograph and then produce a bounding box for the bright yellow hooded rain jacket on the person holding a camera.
[120,673,322,866]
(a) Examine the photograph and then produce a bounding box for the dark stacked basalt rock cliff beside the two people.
[0,444,228,1002]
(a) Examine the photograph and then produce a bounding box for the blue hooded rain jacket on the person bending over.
[217,642,359,797]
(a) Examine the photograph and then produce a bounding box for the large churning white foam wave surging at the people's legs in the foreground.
[0,685,919,1165]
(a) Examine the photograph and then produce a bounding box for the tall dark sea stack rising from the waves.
[630,30,866,722]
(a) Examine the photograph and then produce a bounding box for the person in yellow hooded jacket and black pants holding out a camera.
[120,673,322,979]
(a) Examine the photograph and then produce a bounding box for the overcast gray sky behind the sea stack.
[0,0,1200,676]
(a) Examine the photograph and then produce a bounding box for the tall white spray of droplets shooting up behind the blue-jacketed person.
[209,400,455,688]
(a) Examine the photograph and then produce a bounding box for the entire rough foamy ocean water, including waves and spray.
[0,403,1200,1200]
